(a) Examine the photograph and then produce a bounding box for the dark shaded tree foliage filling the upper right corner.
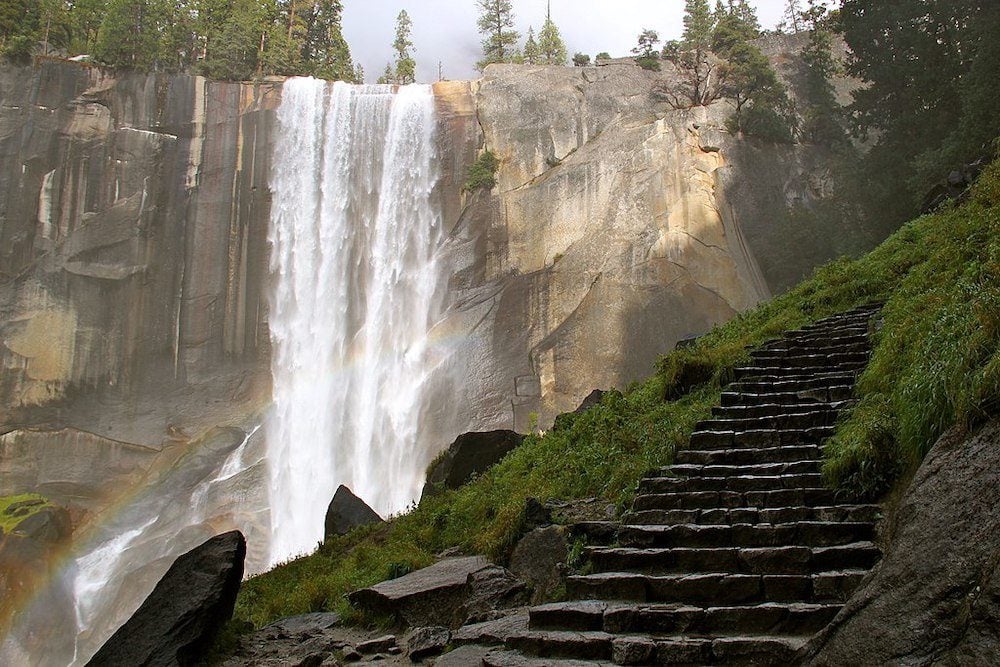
[840,0,1000,221]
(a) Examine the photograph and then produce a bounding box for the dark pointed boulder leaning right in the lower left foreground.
[88,531,247,667]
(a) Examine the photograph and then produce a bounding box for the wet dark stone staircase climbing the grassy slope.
[484,306,880,666]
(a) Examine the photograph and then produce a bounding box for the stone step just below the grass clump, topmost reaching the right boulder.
[622,505,881,526]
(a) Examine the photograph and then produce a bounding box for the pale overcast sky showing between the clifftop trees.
[344,0,786,83]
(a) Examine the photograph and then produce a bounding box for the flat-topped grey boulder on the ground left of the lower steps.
[348,556,527,628]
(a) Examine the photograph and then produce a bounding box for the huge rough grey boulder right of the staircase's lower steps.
[804,421,1000,665]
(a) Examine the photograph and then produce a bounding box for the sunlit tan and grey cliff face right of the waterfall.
[439,58,877,429]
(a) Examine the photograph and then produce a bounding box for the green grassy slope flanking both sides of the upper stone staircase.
[236,166,1000,626]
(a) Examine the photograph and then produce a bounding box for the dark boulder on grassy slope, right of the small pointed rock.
[424,431,524,495]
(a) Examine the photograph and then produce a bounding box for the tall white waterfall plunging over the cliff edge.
[267,78,447,563]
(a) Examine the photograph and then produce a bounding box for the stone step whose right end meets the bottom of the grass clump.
[632,487,837,512]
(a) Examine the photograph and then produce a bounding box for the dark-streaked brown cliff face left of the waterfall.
[0,62,280,430]
